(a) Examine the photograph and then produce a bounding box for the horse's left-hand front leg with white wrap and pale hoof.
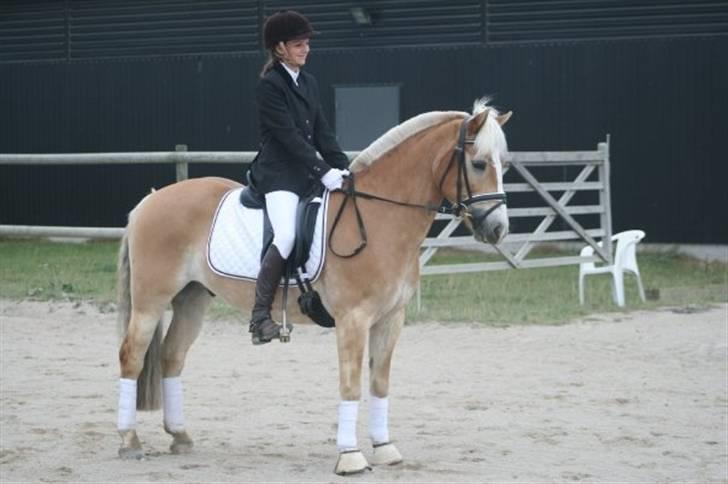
[334,311,371,475]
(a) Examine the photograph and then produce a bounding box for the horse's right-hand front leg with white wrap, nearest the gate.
[369,308,405,465]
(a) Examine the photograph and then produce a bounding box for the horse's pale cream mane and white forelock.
[349,97,500,172]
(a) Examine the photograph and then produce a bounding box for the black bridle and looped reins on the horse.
[328,118,508,259]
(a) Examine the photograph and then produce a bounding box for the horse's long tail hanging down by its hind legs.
[117,227,162,410]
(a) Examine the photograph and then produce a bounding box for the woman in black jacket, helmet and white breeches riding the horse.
[250,10,349,344]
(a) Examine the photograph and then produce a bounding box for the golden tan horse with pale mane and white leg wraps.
[118,100,511,475]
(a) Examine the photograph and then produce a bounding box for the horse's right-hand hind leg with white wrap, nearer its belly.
[162,282,212,454]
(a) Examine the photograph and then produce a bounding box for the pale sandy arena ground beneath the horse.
[0,300,728,483]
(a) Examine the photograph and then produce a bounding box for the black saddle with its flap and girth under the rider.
[240,171,336,328]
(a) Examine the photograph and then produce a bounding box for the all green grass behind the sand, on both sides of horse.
[0,239,728,324]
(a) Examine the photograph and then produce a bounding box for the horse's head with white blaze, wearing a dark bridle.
[440,100,512,244]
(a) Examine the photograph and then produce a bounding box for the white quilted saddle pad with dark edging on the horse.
[207,188,328,284]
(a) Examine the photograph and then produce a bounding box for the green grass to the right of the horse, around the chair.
[416,250,728,324]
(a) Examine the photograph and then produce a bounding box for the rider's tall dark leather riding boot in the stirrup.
[249,245,286,345]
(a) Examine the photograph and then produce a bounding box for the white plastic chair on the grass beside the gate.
[579,230,645,307]
